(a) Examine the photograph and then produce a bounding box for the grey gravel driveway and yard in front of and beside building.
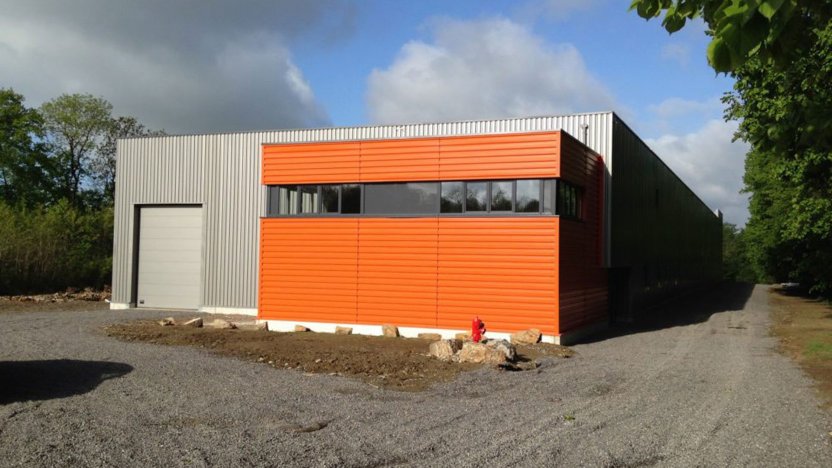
[0,287,832,467]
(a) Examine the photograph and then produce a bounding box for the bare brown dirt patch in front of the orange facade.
[104,321,572,391]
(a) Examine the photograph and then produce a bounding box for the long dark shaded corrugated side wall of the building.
[609,117,722,314]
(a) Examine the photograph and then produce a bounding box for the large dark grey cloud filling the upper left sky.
[0,0,349,132]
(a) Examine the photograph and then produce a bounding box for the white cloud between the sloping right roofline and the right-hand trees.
[645,119,748,226]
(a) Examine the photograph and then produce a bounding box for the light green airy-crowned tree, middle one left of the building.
[41,94,113,206]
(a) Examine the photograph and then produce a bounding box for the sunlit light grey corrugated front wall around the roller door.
[113,112,613,309]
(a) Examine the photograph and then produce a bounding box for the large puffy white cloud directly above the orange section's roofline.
[367,18,614,123]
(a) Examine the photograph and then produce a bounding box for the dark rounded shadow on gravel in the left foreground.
[0,359,133,404]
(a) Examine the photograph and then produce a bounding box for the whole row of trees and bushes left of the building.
[0,88,164,294]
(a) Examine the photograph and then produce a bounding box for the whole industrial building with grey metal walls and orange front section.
[112,112,722,342]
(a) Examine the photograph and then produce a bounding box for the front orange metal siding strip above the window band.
[263,132,561,185]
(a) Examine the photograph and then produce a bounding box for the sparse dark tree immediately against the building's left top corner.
[90,117,165,203]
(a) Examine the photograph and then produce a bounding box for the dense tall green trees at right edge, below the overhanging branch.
[724,21,832,294]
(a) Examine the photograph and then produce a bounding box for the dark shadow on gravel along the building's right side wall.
[579,283,754,344]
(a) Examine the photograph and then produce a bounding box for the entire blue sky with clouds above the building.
[0,0,748,225]
